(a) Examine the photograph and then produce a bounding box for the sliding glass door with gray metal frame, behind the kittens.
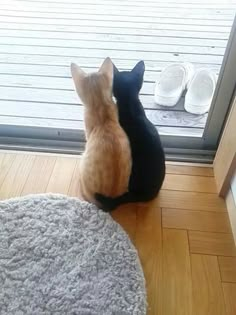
[0,0,236,161]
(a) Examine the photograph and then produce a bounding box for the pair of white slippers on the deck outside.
[154,63,216,114]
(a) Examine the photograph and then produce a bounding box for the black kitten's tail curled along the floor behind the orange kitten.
[95,192,157,212]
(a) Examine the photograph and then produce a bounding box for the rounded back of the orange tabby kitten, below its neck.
[81,119,131,200]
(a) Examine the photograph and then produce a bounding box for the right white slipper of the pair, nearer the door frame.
[184,69,216,115]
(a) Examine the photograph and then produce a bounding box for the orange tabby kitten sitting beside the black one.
[71,58,131,207]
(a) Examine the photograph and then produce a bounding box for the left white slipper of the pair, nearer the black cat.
[154,63,194,107]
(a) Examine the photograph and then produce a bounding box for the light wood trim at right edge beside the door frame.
[214,97,236,197]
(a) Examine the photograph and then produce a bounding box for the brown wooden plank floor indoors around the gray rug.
[0,152,236,315]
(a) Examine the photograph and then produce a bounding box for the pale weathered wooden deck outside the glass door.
[0,0,236,136]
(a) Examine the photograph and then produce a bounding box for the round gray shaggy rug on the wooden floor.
[0,194,146,315]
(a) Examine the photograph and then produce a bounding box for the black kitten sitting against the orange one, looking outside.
[95,61,165,211]
